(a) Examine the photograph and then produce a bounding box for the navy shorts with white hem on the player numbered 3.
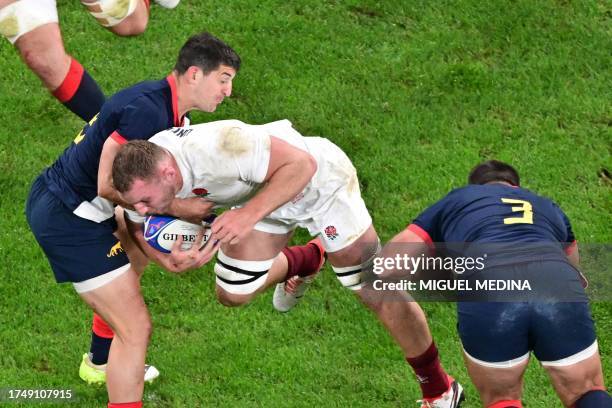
[457,262,597,367]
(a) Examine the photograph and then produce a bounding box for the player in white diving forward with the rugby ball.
[112,120,462,408]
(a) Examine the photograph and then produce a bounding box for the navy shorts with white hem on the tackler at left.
[26,177,129,283]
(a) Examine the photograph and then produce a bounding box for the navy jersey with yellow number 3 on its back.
[408,183,575,266]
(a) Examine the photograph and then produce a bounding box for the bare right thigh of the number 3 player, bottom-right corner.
[544,350,605,406]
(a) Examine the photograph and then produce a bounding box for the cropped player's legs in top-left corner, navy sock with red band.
[0,0,180,122]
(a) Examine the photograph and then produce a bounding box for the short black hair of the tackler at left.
[174,33,240,74]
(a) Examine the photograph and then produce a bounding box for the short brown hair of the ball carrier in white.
[113,140,165,193]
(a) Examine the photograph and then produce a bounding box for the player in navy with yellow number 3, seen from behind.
[382,160,612,408]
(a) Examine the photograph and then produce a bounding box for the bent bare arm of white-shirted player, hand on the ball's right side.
[212,136,317,244]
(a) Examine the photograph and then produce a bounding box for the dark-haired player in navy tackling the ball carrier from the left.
[26,33,240,407]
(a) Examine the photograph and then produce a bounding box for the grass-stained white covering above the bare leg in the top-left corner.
[0,0,58,44]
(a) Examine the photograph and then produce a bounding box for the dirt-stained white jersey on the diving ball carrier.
[130,120,358,221]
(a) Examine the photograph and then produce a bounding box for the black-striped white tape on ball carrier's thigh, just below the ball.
[215,250,274,295]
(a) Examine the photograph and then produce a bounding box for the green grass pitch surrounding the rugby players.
[0,0,612,408]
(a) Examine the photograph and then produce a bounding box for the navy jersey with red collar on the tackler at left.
[43,75,184,222]
